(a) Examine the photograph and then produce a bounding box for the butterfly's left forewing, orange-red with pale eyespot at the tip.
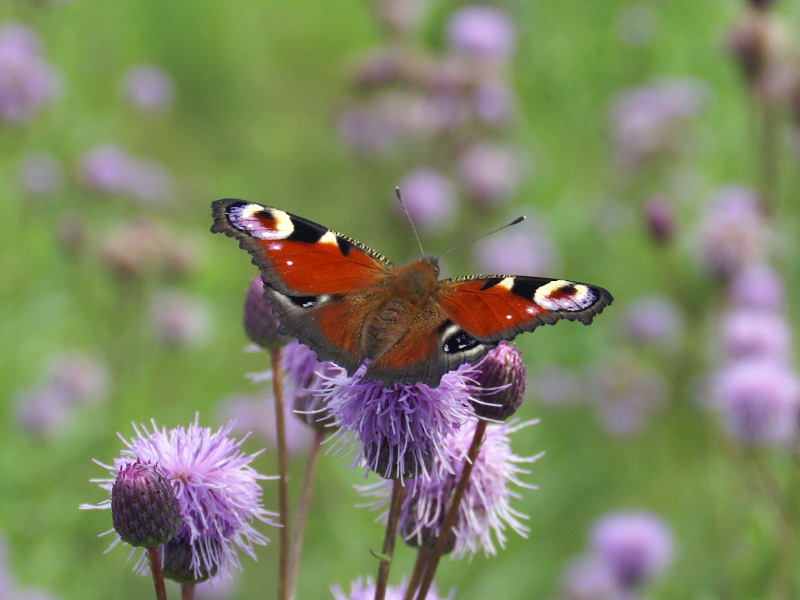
[211,199,394,296]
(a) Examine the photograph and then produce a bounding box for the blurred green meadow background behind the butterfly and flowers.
[0,0,800,600]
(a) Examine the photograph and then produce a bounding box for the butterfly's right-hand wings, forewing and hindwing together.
[367,276,613,386]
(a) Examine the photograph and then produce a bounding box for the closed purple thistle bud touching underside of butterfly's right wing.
[472,342,525,421]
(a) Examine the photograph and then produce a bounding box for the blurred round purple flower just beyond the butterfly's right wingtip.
[625,296,683,349]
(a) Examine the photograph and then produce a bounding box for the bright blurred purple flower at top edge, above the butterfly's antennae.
[447,4,516,60]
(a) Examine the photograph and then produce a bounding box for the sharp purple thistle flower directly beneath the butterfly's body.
[317,363,482,479]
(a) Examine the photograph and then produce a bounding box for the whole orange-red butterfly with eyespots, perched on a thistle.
[211,199,613,387]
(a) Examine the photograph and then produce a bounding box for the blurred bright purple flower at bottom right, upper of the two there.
[591,512,673,588]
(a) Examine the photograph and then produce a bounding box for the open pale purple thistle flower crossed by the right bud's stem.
[359,419,543,558]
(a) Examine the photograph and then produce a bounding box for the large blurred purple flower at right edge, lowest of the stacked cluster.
[712,359,800,445]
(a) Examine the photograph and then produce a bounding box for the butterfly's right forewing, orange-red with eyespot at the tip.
[439,276,613,341]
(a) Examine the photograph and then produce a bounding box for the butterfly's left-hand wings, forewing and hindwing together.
[211,199,395,373]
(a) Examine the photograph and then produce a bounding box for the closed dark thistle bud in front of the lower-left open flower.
[111,461,182,548]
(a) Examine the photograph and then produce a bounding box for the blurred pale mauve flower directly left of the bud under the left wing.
[150,291,212,347]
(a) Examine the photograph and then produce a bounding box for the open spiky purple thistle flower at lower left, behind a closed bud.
[80,415,275,579]
